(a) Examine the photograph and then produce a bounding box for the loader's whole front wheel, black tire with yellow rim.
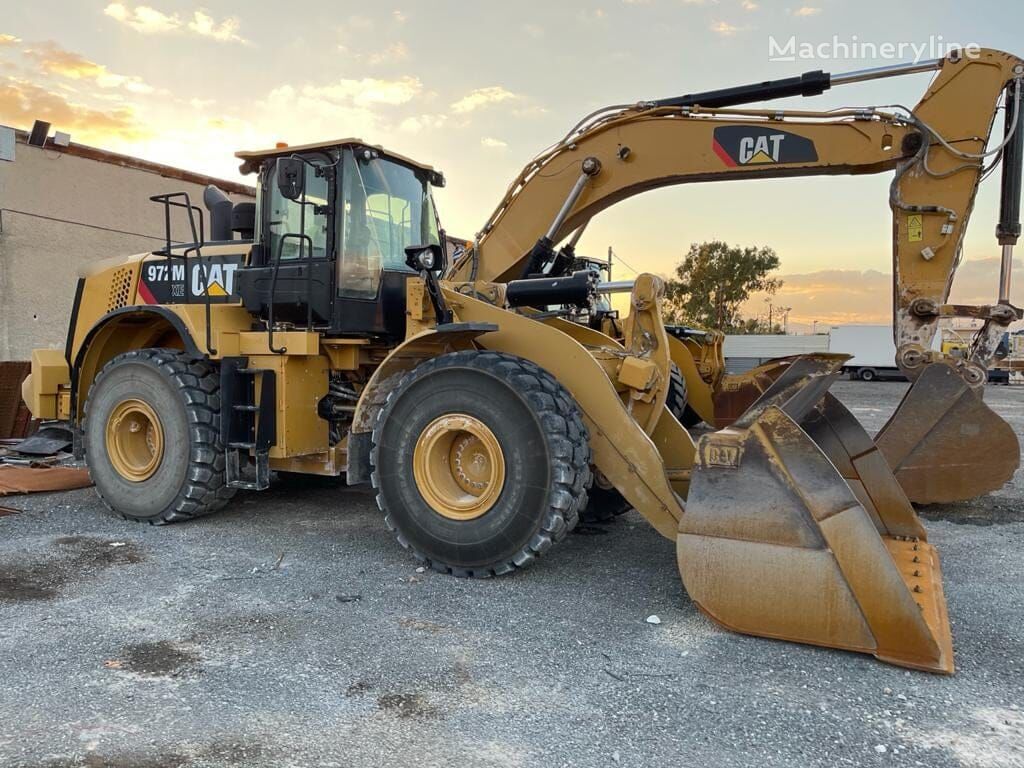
[371,350,592,578]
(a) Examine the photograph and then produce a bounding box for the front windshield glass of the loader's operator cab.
[338,150,440,298]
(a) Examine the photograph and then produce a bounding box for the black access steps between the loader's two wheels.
[220,357,278,490]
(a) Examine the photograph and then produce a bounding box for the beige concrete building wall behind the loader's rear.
[0,132,253,360]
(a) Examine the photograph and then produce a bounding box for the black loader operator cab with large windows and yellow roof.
[237,139,444,340]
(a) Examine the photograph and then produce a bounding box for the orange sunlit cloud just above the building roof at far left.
[0,77,148,143]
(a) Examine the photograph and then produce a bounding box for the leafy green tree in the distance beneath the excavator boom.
[665,240,782,333]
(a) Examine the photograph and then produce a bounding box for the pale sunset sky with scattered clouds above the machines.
[0,0,1024,331]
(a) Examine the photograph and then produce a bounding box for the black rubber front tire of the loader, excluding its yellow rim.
[370,350,593,578]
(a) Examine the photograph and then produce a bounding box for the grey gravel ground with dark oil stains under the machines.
[0,382,1024,768]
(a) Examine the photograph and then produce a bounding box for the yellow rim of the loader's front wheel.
[413,414,505,520]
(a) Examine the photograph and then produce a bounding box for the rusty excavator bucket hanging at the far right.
[874,362,1021,504]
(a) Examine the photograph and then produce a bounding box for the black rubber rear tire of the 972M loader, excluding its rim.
[82,349,236,525]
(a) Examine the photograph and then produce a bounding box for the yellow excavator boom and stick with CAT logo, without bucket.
[449,49,1024,381]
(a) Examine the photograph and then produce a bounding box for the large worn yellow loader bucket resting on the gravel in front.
[677,355,953,674]
